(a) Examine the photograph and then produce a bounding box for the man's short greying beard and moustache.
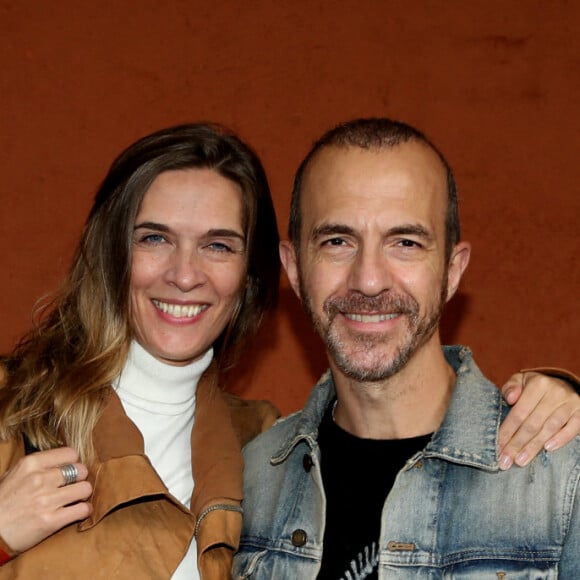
[300,272,447,382]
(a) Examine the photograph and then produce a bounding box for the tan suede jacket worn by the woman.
[0,373,279,580]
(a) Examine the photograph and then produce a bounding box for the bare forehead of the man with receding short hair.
[300,141,448,237]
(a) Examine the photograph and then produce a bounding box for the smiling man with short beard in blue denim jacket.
[234,119,580,580]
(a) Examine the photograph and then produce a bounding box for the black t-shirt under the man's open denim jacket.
[318,405,431,580]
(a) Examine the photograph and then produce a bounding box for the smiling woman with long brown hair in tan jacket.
[0,124,576,579]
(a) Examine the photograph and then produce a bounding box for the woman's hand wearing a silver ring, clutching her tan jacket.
[0,447,92,552]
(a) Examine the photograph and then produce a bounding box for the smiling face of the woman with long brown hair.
[130,169,246,365]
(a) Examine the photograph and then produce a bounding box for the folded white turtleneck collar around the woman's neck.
[113,340,213,415]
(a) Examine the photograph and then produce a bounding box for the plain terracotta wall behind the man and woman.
[0,0,580,412]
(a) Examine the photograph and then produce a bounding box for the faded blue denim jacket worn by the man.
[233,347,580,580]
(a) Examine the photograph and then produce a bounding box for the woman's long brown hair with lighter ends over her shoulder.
[0,123,280,462]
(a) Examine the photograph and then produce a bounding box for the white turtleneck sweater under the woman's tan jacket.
[114,341,213,580]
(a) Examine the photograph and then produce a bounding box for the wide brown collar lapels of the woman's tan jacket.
[81,363,243,529]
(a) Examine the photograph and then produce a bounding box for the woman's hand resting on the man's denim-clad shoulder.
[499,372,580,469]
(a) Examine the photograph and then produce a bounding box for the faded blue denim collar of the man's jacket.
[271,346,507,471]
